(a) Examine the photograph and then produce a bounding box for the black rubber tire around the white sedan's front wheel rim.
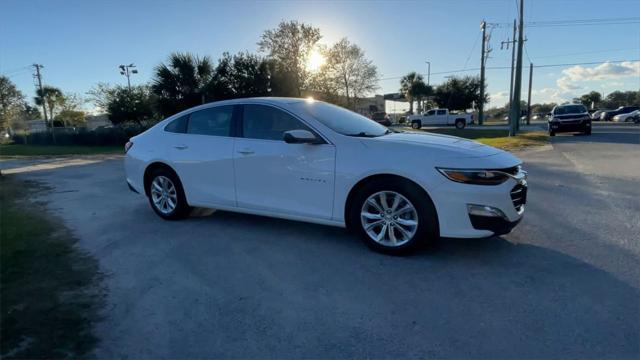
[347,178,440,255]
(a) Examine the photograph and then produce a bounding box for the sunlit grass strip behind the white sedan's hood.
[425,129,549,150]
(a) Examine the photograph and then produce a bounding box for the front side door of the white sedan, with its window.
[234,104,335,219]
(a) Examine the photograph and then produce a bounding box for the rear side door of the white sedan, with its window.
[167,105,236,206]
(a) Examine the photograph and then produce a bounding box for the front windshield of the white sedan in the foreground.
[292,101,389,137]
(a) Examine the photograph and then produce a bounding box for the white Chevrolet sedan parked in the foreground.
[125,98,527,253]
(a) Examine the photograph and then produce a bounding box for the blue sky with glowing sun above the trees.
[0,0,640,112]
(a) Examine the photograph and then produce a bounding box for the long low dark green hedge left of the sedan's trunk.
[13,125,149,146]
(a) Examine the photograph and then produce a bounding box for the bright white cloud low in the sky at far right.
[556,61,640,91]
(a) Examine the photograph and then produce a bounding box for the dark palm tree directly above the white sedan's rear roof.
[151,53,213,116]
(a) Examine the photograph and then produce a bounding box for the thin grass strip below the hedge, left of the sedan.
[0,144,123,157]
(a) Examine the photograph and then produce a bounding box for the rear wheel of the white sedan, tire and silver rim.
[147,168,191,220]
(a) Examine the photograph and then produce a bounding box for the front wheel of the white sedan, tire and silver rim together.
[348,179,439,254]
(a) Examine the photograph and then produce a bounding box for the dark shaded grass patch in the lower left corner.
[0,176,103,359]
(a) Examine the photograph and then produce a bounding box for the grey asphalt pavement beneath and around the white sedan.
[4,127,640,359]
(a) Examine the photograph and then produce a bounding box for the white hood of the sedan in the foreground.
[372,133,504,157]
